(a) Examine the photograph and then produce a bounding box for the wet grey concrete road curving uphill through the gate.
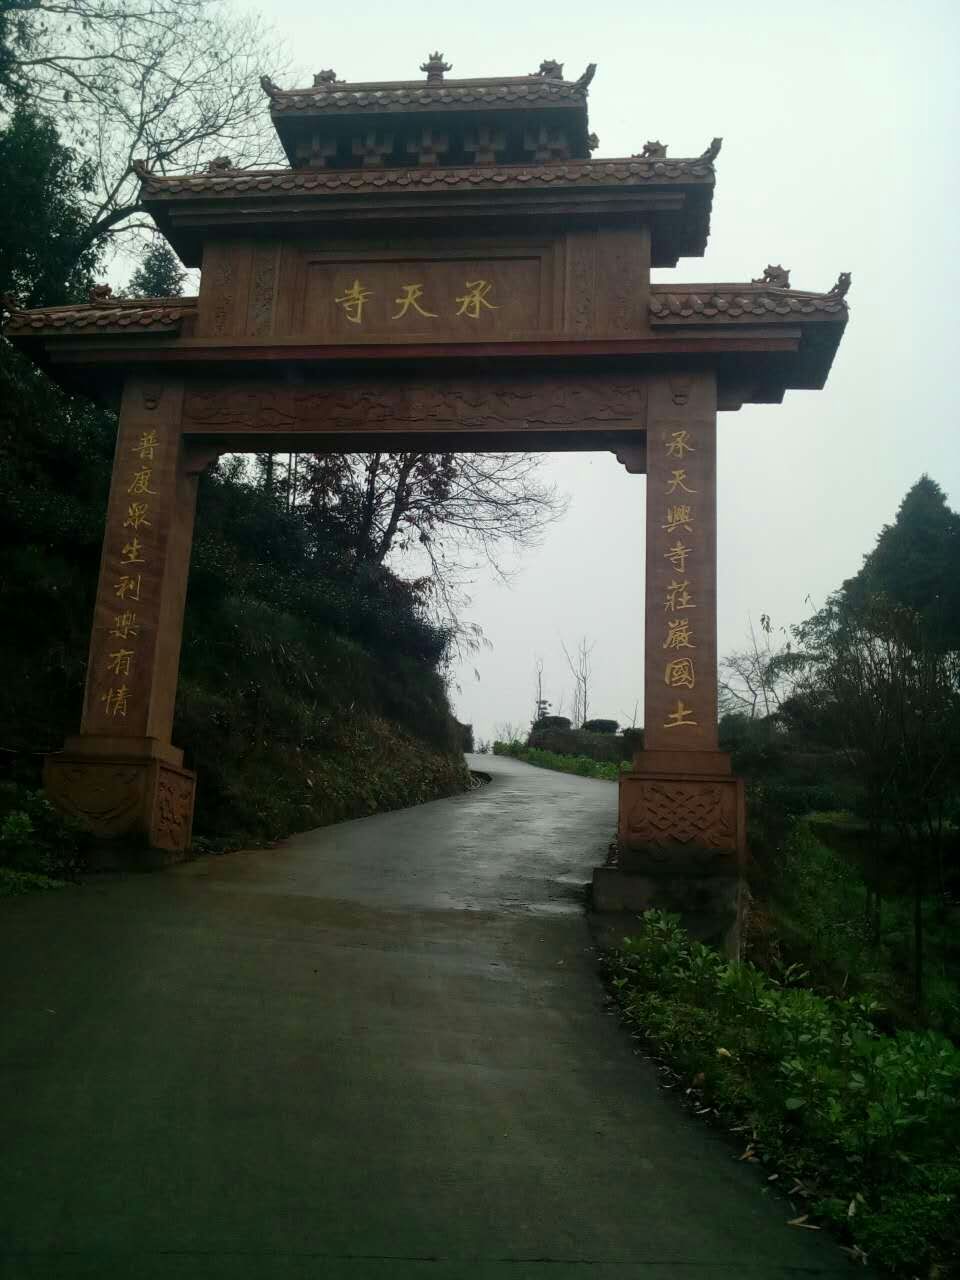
[0,756,849,1280]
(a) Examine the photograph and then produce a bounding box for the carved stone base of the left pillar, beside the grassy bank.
[44,736,196,861]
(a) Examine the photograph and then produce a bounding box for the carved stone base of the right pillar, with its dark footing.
[593,751,745,954]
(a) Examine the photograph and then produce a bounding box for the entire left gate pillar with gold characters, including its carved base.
[44,378,210,854]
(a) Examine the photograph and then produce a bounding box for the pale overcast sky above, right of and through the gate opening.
[257,0,960,737]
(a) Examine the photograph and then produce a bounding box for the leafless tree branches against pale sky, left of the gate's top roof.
[0,0,283,259]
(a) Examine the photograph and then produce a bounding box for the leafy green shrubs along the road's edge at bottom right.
[609,911,960,1275]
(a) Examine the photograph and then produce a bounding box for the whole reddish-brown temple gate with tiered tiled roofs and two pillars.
[6,54,849,909]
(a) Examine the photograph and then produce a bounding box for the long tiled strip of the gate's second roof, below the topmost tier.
[142,157,714,200]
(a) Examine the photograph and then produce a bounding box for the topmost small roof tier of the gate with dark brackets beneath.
[262,54,594,169]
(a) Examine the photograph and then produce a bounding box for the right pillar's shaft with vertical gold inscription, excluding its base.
[645,378,717,750]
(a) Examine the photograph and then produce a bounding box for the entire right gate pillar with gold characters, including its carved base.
[594,374,744,948]
